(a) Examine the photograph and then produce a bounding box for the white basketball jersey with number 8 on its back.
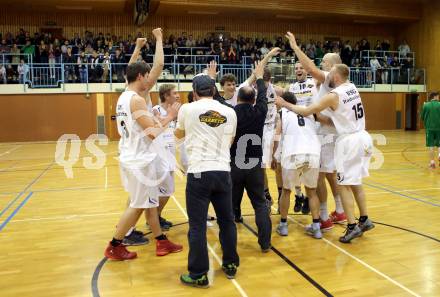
[280,108,321,159]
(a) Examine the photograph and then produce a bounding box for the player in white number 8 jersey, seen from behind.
[274,92,322,239]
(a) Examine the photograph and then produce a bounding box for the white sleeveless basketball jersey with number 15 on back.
[331,82,365,135]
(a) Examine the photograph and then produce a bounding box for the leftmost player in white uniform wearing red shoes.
[105,62,183,260]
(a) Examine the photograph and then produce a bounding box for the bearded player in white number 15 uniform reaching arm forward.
[277,64,374,243]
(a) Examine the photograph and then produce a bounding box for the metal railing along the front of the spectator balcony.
[0,62,426,89]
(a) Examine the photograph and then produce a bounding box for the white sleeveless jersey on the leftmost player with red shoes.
[116,91,157,168]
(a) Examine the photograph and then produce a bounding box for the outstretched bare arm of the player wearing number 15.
[275,93,339,117]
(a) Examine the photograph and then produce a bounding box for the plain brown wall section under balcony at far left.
[0,94,97,142]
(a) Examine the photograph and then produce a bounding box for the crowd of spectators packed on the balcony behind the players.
[0,29,413,83]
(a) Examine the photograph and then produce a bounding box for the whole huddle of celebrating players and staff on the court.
[105,29,374,286]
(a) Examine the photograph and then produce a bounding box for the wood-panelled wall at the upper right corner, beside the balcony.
[399,1,440,90]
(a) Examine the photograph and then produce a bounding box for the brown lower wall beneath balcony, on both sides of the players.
[0,92,412,142]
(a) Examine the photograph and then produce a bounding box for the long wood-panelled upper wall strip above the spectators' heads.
[0,12,398,46]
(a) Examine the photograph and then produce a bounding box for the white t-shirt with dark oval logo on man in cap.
[177,98,237,173]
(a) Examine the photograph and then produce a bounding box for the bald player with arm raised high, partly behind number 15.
[286,32,346,230]
